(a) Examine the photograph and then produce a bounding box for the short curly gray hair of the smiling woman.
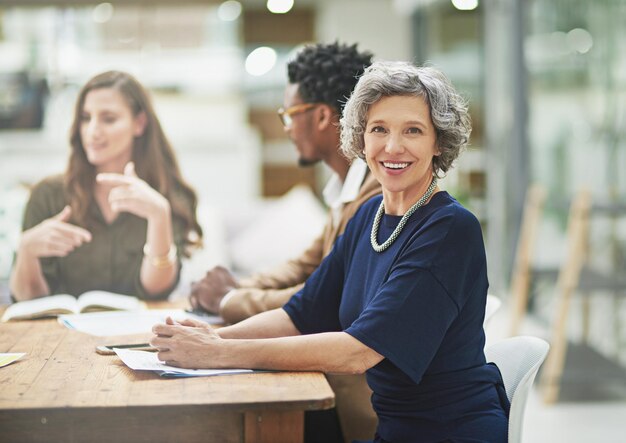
[340,61,472,177]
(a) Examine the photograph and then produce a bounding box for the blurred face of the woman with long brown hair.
[80,88,145,172]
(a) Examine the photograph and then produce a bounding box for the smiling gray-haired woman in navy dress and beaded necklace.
[152,62,509,442]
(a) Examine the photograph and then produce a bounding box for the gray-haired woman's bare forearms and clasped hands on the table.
[150,309,383,374]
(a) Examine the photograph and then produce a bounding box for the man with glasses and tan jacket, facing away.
[190,43,381,443]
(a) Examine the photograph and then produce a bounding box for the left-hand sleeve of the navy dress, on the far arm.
[283,236,346,334]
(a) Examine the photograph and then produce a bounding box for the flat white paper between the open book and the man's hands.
[58,309,221,337]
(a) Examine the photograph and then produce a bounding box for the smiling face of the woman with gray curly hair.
[364,96,438,215]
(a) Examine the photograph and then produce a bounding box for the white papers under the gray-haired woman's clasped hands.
[114,348,253,377]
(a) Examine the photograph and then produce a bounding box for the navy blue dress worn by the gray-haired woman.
[284,192,509,443]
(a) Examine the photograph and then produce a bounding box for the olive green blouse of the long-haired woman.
[22,175,189,299]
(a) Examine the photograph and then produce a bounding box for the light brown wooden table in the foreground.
[0,309,334,443]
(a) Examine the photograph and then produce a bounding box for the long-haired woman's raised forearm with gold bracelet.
[139,206,178,294]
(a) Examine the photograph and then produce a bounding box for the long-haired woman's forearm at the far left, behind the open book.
[9,247,50,301]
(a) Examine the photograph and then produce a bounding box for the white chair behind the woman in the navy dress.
[485,336,550,443]
